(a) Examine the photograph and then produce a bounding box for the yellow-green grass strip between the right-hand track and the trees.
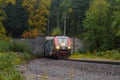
[69,50,120,60]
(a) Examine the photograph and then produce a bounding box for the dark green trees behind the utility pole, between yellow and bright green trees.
[50,0,91,37]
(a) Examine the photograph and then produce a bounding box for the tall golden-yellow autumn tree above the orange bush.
[22,0,51,34]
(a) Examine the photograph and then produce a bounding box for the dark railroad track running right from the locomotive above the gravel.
[64,59,120,65]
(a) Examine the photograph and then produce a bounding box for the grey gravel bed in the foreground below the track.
[18,59,120,80]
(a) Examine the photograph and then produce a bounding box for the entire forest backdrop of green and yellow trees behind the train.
[0,0,120,51]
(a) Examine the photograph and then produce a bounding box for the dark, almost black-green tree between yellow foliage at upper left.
[3,0,28,38]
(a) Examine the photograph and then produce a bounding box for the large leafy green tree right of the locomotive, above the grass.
[83,0,120,51]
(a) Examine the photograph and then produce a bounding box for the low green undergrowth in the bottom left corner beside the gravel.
[0,52,30,80]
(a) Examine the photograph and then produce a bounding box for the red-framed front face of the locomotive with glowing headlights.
[54,36,71,56]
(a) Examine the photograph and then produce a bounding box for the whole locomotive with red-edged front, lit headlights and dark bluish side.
[44,36,71,59]
